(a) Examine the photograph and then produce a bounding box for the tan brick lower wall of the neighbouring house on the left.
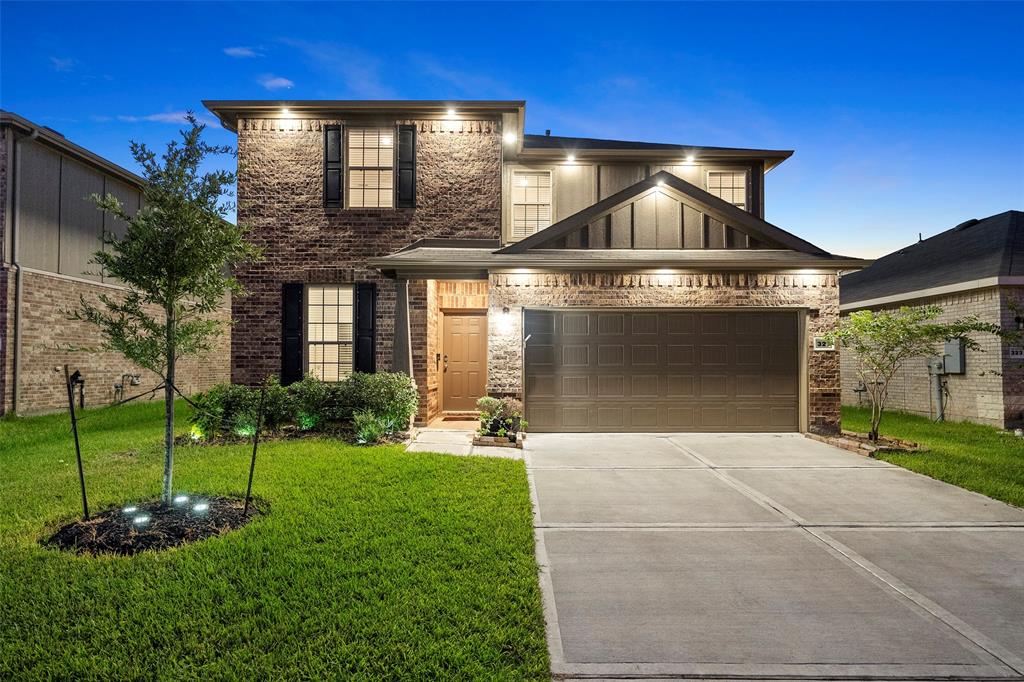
[0,271,230,414]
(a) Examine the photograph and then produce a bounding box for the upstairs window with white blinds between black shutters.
[345,128,394,208]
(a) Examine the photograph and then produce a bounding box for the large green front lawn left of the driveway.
[0,403,549,680]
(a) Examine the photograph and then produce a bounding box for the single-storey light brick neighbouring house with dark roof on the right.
[841,211,1024,428]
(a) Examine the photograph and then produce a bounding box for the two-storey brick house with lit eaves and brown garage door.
[205,101,864,431]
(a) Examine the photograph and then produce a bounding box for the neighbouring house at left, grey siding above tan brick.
[0,112,230,415]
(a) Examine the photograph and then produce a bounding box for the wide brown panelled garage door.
[523,309,800,432]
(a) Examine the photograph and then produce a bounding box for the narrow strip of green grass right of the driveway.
[843,407,1024,507]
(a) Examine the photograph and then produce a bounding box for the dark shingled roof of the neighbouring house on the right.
[840,211,1024,305]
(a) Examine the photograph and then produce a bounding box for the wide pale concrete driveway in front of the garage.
[525,434,1024,679]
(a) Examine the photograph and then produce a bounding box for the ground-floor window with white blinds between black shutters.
[306,285,353,381]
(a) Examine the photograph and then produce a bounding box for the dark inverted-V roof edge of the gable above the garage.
[498,171,830,257]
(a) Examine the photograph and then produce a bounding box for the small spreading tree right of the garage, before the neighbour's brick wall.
[828,305,1000,441]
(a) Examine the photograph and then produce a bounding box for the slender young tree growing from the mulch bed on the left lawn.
[72,113,259,502]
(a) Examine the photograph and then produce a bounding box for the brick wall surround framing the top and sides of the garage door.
[487,272,840,432]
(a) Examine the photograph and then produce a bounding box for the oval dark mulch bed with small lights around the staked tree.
[43,496,269,556]
